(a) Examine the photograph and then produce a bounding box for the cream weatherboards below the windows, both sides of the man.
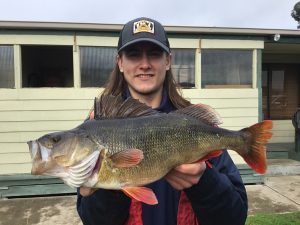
[0,88,258,174]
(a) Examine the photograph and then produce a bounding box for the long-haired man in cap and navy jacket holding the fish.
[77,18,247,225]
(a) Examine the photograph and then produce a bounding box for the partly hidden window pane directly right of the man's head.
[172,49,195,87]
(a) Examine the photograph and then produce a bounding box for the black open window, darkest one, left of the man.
[21,45,74,87]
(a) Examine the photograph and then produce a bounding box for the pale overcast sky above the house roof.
[0,0,299,29]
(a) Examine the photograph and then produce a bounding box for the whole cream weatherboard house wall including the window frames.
[0,32,284,174]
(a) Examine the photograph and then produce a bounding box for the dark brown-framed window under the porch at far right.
[262,64,300,120]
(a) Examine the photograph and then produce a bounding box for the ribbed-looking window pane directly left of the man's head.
[80,47,117,87]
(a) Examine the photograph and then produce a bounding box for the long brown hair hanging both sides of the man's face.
[101,55,191,109]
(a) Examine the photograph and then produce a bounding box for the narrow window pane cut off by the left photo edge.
[0,46,15,88]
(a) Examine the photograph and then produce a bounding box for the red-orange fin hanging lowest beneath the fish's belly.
[122,187,158,205]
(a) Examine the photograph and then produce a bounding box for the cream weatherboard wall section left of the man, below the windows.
[0,88,99,174]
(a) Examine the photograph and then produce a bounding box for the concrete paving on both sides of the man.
[0,175,300,225]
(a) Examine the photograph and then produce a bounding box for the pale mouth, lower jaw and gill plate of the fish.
[27,140,100,188]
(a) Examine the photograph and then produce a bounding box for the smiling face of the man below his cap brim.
[118,42,171,97]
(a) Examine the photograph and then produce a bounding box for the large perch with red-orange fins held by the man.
[28,96,272,204]
